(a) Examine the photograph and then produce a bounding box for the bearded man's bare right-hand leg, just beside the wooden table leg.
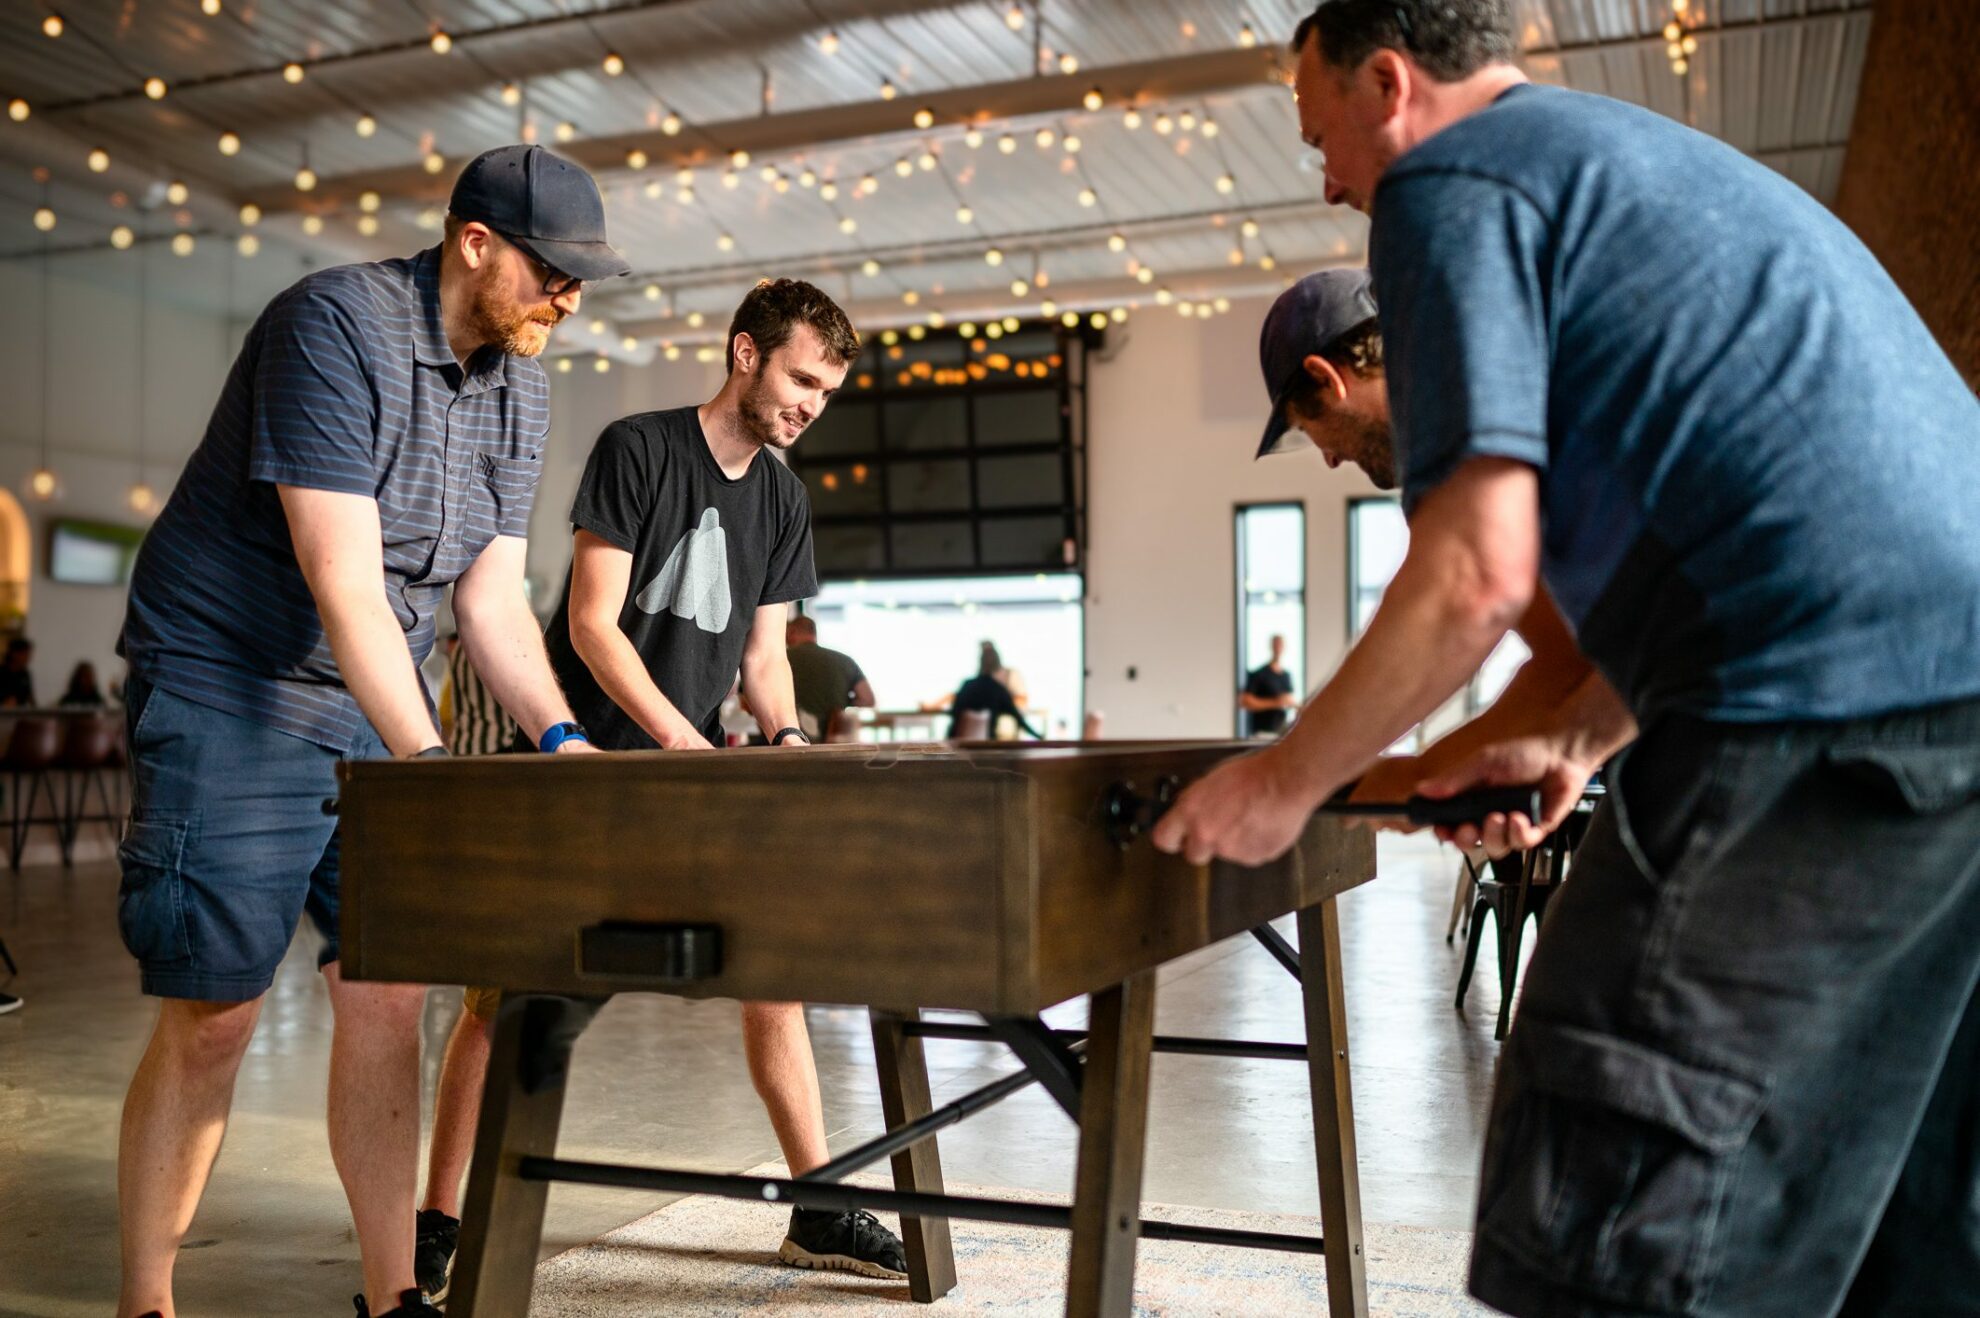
[323,964,426,1314]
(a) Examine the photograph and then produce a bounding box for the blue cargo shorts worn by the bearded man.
[117,673,386,1001]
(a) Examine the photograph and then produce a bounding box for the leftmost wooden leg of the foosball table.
[447,995,598,1318]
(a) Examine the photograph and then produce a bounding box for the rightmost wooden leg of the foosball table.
[1299,898,1368,1318]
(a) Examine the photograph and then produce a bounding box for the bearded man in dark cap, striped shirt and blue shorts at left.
[117,146,628,1318]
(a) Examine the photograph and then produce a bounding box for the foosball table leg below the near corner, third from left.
[1065,970,1154,1318]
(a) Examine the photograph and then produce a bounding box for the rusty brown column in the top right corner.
[1835,0,1980,388]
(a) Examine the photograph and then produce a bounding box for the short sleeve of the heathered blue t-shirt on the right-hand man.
[1368,170,1552,509]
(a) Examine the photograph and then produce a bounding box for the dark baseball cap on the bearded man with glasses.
[447,144,632,283]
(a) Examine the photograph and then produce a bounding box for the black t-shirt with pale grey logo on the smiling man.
[545,408,818,750]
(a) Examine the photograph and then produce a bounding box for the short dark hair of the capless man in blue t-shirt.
[1293,0,1519,83]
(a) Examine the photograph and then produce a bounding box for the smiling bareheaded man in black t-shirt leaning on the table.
[436,279,907,1280]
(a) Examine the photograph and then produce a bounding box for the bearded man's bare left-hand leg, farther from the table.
[117,997,261,1318]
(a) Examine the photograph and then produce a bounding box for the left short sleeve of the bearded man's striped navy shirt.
[248,293,378,497]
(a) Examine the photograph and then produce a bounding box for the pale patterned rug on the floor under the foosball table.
[531,1164,1493,1318]
